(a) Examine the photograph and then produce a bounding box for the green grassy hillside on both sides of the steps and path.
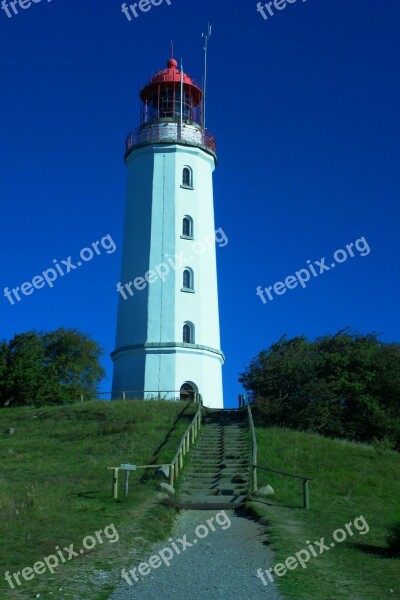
[0,401,400,600]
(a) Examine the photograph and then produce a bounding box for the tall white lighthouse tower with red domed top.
[111,59,224,408]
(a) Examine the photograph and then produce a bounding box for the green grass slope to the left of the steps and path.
[0,401,197,600]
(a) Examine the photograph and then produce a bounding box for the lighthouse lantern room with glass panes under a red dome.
[140,58,202,126]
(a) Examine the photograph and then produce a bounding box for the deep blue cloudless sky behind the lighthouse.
[0,0,400,406]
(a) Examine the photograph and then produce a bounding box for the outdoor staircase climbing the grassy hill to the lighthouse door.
[179,409,250,510]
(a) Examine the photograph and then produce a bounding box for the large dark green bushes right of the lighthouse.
[239,330,400,449]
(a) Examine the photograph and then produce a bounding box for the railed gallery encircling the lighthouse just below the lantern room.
[126,121,217,154]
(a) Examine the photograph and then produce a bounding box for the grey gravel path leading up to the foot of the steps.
[110,510,281,600]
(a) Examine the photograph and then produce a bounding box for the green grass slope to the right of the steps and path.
[249,427,400,600]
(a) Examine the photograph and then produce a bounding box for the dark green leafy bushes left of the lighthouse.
[0,328,105,406]
